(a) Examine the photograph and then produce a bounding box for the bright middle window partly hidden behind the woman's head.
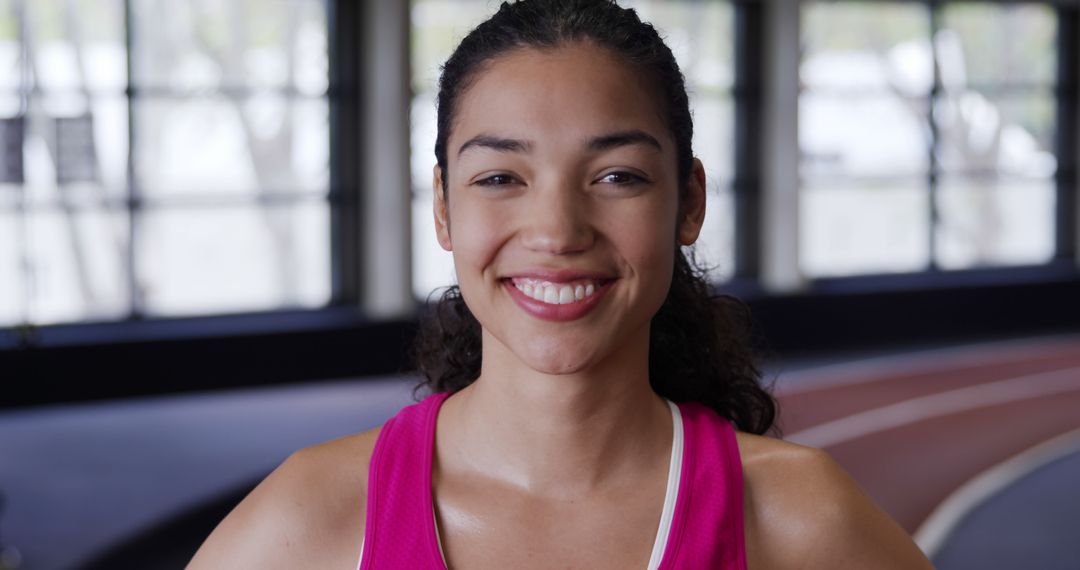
[410,0,734,299]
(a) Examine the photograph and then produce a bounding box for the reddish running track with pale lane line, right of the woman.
[777,336,1080,554]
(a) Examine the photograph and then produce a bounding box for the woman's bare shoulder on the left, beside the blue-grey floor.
[188,429,379,569]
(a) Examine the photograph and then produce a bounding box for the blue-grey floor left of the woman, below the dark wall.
[0,378,413,570]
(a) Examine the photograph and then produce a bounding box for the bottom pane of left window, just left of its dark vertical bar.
[15,207,129,324]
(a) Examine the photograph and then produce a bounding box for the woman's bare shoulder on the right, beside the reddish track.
[738,433,932,570]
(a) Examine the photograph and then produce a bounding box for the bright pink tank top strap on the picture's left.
[360,393,449,570]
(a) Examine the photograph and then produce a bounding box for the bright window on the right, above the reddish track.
[799,2,1058,277]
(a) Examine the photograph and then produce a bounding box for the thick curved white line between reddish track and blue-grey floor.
[915,430,1080,558]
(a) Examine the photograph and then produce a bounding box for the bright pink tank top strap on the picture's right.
[660,403,746,570]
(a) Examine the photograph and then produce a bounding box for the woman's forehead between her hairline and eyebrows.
[449,43,674,154]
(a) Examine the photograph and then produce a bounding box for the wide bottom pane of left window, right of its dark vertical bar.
[135,200,330,316]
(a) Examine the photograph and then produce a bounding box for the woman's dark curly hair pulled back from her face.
[414,0,777,434]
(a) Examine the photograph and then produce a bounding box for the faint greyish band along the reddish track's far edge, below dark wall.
[775,335,1080,397]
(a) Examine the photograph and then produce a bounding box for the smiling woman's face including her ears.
[435,44,704,374]
